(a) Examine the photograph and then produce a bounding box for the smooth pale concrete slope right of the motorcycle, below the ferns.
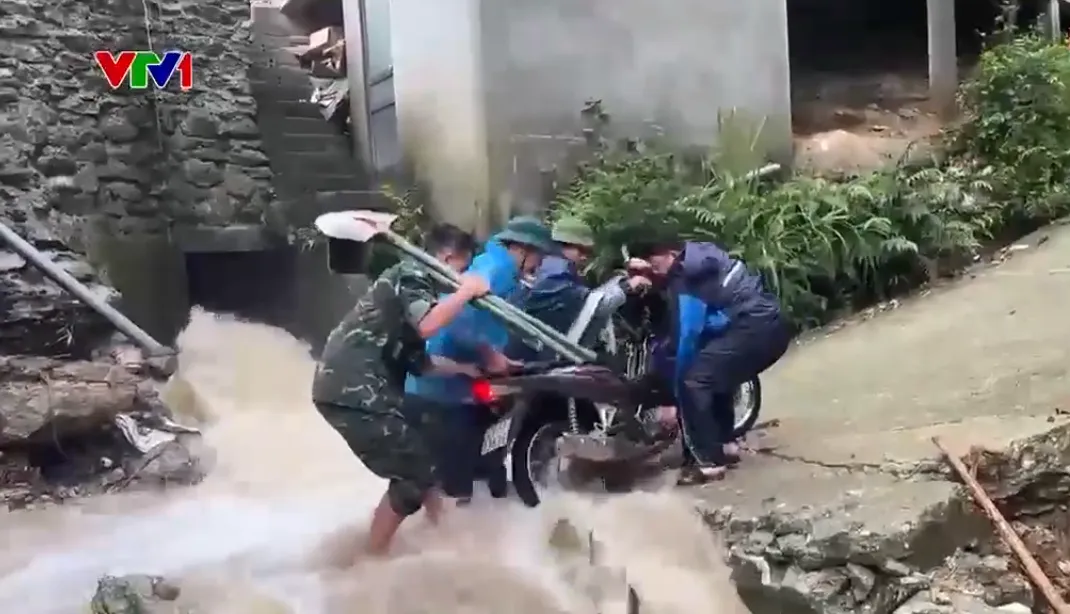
[763,221,1070,464]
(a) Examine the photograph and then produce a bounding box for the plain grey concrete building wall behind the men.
[391,0,791,231]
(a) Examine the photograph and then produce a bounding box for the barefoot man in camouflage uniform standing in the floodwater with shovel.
[312,225,488,555]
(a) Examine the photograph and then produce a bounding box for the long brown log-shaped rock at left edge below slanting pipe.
[0,356,166,449]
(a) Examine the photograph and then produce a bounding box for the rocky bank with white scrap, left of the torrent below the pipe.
[0,356,210,508]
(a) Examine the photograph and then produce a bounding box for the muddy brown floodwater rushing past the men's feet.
[0,311,746,614]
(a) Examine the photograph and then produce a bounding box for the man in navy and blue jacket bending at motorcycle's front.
[628,241,794,483]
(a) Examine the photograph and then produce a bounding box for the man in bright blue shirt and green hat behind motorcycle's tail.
[406,216,555,502]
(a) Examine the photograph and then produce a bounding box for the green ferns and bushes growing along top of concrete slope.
[550,33,1070,325]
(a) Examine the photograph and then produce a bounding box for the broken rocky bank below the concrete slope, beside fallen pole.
[702,426,1070,614]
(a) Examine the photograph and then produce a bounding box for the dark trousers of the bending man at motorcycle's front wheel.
[676,318,794,464]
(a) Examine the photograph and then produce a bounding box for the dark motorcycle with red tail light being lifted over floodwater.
[472,276,762,507]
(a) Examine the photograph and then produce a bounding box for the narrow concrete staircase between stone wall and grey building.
[249,0,384,227]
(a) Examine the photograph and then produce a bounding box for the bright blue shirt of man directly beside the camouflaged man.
[404,237,520,402]
